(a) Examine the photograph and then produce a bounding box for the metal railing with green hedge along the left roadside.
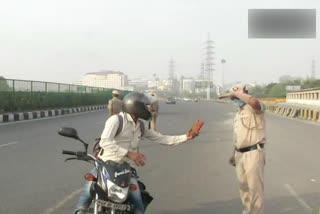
[0,78,129,113]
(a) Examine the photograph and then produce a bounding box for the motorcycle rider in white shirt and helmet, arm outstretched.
[74,92,198,214]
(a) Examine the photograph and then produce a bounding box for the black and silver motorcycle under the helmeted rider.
[58,127,152,214]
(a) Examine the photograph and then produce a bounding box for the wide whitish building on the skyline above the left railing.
[82,71,129,90]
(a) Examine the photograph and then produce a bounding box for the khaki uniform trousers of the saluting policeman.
[235,148,265,214]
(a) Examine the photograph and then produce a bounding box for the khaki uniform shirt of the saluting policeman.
[233,102,266,149]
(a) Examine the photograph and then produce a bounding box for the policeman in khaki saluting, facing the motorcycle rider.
[219,84,266,214]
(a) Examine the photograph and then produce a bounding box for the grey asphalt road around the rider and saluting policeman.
[0,101,320,214]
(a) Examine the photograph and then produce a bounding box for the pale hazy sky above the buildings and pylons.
[0,0,320,83]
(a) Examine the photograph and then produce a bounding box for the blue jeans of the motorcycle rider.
[74,168,144,214]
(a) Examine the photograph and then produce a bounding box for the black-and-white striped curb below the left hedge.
[0,105,107,123]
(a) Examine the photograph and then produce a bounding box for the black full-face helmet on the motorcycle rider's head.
[123,92,151,120]
